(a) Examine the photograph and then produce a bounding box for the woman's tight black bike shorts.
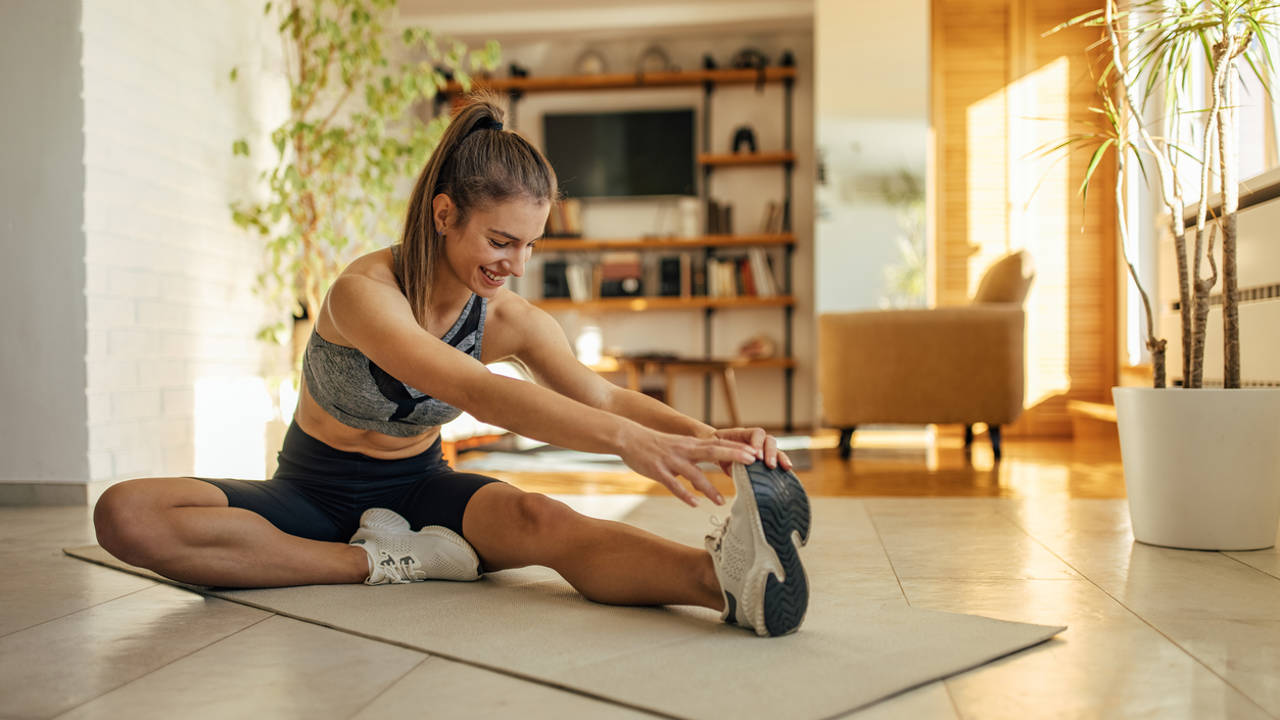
[196,423,502,542]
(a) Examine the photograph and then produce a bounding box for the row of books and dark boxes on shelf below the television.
[541,247,786,302]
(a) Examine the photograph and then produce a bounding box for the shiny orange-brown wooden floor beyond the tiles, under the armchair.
[476,430,1125,500]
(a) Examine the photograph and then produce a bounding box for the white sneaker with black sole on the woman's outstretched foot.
[707,460,810,637]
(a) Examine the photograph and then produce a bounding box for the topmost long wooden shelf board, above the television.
[445,68,796,94]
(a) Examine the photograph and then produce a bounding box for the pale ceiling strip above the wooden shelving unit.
[398,0,814,41]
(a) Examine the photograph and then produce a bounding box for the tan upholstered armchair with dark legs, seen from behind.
[818,252,1032,460]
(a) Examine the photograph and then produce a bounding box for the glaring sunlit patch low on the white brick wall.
[195,377,273,479]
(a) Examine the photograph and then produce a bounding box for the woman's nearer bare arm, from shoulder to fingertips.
[328,274,754,505]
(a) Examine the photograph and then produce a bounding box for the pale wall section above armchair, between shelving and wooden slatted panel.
[814,0,929,313]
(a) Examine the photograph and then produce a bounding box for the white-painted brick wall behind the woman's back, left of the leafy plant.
[82,0,287,480]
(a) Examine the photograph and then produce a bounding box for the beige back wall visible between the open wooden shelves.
[483,30,814,427]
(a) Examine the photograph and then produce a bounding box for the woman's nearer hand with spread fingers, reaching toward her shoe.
[620,428,763,507]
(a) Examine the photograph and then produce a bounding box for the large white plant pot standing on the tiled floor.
[1111,387,1280,550]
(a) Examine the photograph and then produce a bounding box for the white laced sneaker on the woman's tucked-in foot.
[351,507,480,585]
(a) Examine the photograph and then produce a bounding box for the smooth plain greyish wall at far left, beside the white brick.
[0,0,88,503]
